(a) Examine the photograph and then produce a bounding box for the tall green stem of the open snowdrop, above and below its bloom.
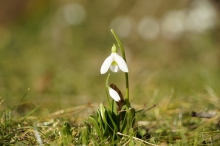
[111,29,130,108]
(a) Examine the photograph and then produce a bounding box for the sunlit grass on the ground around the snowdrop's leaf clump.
[0,89,220,145]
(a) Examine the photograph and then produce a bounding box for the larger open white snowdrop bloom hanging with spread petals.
[100,45,128,74]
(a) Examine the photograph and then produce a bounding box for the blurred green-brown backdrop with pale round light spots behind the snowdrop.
[0,0,220,109]
